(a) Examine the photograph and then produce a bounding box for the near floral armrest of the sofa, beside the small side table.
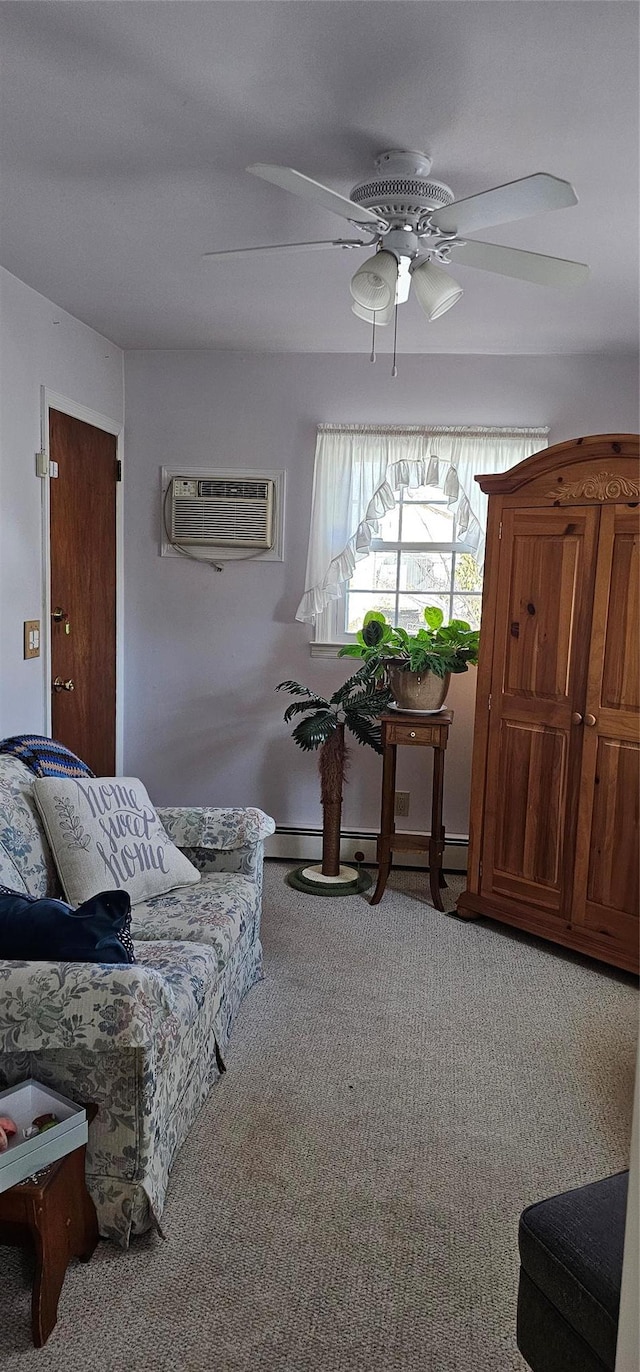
[0,962,176,1054]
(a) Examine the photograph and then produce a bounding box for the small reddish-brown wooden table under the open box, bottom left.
[0,1106,99,1349]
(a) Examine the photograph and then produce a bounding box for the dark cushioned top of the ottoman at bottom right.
[519,1172,629,1368]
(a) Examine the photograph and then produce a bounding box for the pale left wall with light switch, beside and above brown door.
[0,268,124,738]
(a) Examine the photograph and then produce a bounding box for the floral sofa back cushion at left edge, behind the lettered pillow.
[0,756,59,897]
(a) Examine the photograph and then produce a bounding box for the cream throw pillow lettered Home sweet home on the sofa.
[33,777,201,906]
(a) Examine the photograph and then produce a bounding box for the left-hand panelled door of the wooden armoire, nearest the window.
[481,508,600,923]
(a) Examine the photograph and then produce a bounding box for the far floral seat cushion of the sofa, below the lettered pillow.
[132,871,258,971]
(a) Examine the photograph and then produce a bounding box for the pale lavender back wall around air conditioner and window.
[125,351,637,834]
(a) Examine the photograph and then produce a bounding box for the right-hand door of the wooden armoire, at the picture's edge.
[573,505,640,955]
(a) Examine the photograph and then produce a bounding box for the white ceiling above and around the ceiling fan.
[0,0,639,353]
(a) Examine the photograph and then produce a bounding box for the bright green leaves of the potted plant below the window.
[338,605,479,679]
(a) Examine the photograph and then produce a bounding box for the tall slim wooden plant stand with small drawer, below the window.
[371,709,453,910]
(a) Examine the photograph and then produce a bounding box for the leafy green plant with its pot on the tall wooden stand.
[338,605,479,713]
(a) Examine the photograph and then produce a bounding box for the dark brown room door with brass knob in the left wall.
[49,410,117,777]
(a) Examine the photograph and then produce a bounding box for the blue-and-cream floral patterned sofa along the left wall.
[0,756,275,1244]
